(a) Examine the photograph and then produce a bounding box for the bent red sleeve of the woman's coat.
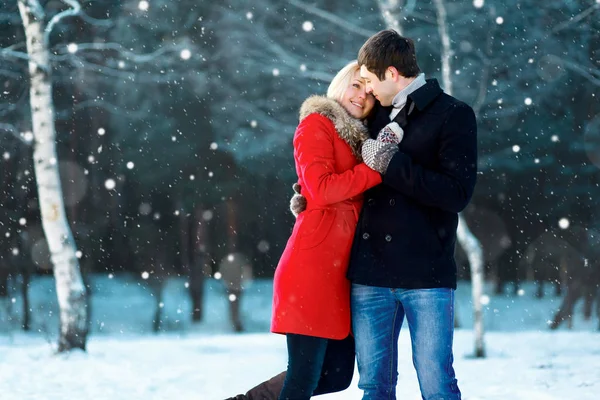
[294,114,381,206]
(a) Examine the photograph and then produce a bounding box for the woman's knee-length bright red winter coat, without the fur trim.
[271,98,381,339]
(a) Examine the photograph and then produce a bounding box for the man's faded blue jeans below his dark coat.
[351,284,461,400]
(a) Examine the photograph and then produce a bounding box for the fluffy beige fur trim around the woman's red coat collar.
[300,95,369,161]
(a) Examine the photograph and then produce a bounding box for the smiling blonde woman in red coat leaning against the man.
[225,61,381,400]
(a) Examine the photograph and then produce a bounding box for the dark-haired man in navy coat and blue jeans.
[348,30,477,400]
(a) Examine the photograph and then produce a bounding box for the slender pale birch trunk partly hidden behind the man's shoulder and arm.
[434,0,485,357]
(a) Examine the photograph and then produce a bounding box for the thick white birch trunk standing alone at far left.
[18,0,88,352]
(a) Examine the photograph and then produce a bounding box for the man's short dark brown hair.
[358,29,421,80]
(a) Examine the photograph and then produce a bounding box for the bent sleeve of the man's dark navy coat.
[383,104,477,213]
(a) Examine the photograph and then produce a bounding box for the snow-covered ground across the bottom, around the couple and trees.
[0,276,600,400]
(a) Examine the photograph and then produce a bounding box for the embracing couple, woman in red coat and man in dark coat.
[226,30,477,400]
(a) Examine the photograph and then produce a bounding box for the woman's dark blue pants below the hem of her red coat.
[279,334,355,400]
